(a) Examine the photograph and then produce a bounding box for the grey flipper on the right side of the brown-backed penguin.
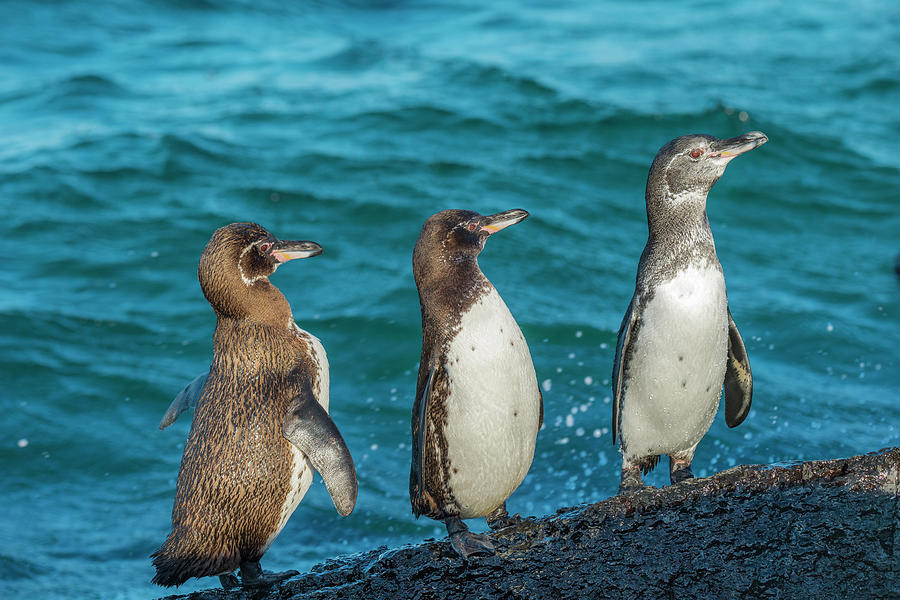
[283,384,357,517]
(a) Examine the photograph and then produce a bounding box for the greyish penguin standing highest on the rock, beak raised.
[612,131,768,492]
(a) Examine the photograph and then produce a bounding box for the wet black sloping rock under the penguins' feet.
[162,448,900,600]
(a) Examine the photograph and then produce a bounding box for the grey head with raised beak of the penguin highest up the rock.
[647,131,769,201]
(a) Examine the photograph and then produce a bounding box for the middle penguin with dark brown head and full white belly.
[409,209,543,559]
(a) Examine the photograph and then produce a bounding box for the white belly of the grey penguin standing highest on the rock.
[620,265,728,459]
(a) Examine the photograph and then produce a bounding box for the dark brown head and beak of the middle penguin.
[413,208,528,266]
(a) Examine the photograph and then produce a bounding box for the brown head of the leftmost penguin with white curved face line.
[197,223,322,318]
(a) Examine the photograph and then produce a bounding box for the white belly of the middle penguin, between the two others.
[444,288,540,518]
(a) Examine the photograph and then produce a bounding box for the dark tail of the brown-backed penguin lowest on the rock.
[150,530,241,587]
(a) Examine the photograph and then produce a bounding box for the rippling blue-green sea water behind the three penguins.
[0,0,900,599]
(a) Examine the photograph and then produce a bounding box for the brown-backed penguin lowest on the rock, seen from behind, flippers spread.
[151,223,357,589]
